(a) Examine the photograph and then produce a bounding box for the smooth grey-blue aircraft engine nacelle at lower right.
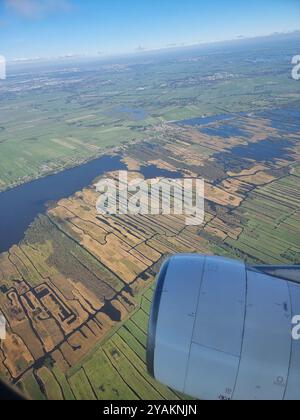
[147,255,300,400]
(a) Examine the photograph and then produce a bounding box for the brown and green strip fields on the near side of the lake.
[0,99,300,399]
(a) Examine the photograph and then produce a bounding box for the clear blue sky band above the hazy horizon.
[0,0,300,59]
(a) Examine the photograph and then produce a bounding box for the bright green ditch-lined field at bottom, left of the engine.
[27,288,181,400]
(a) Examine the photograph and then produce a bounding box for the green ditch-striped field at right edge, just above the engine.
[226,176,300,264]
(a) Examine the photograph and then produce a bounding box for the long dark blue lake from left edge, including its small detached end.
[0,156,181,253]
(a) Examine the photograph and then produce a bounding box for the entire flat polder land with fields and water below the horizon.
[0,33,300,400]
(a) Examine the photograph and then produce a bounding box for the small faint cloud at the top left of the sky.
[4,0,71,19]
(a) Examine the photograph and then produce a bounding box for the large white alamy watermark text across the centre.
[96,171,205,226]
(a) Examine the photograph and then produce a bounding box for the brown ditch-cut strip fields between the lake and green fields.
[0,110,300,399]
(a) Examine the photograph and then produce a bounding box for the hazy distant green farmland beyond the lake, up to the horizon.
[0,36,300,191]
